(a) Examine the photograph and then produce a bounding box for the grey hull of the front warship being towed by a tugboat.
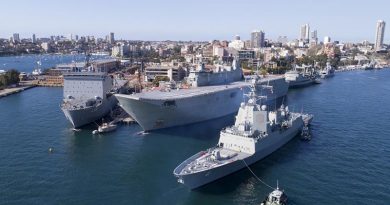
[174,120,303,189]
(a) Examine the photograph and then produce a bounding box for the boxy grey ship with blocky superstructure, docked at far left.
[61,70,118,128]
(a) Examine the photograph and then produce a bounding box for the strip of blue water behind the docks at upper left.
[0,54,109,73]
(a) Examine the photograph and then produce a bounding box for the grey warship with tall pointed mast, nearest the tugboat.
[173,85,304,189]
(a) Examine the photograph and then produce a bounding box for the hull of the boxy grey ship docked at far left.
[61,96,118,128]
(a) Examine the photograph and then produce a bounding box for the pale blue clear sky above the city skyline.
[0,0,390,43]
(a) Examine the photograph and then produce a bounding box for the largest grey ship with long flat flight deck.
[115,60,288,131]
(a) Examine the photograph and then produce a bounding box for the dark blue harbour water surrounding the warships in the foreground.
[0,60,390,205]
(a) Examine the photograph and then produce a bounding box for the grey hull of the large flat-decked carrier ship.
[115,81,288,131]
